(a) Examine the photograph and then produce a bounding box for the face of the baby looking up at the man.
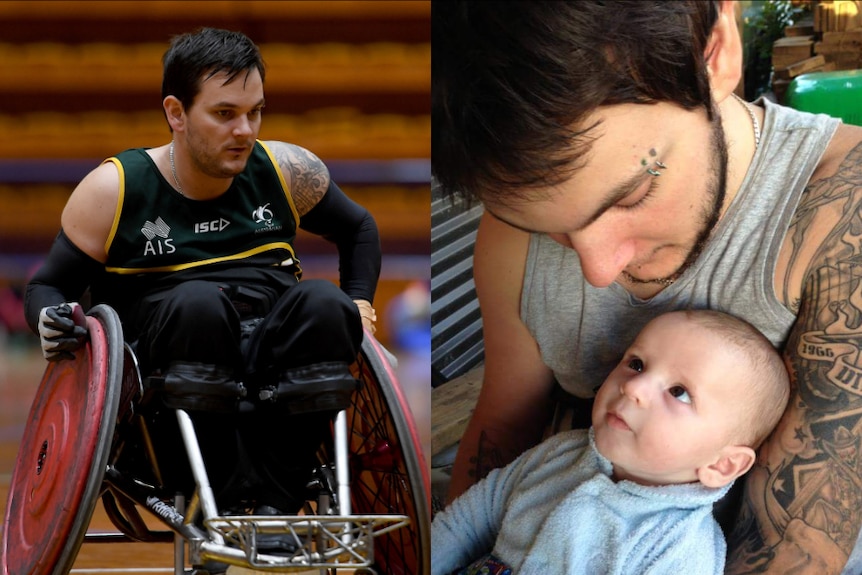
[593,314,749,484]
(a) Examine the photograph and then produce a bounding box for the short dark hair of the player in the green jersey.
[162,28,265,110]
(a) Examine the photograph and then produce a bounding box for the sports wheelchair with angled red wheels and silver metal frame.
[0,305,430,575]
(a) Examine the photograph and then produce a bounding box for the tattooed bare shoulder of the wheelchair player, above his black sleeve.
[270,142,329,216]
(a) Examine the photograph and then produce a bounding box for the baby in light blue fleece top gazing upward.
[431,310,789,575]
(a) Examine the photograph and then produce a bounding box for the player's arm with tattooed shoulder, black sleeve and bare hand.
[266,138,381,322]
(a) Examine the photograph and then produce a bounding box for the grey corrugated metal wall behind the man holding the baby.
[431,181,484,387]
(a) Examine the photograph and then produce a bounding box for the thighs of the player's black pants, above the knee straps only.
[135,280,362,382]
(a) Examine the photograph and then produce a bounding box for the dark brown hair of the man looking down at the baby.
[431,0,718,202]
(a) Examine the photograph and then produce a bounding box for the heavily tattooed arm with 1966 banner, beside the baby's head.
[727,136,862,575]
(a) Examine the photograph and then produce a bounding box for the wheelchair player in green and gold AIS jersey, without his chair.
[25,29,381,564]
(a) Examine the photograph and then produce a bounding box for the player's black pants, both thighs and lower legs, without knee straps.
[130,280,362,513]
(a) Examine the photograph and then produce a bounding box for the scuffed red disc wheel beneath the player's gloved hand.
[0,306,123,575]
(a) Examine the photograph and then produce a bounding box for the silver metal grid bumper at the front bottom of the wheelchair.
[196,515,410,572]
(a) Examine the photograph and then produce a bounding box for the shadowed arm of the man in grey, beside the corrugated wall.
[448,213,553,501]
